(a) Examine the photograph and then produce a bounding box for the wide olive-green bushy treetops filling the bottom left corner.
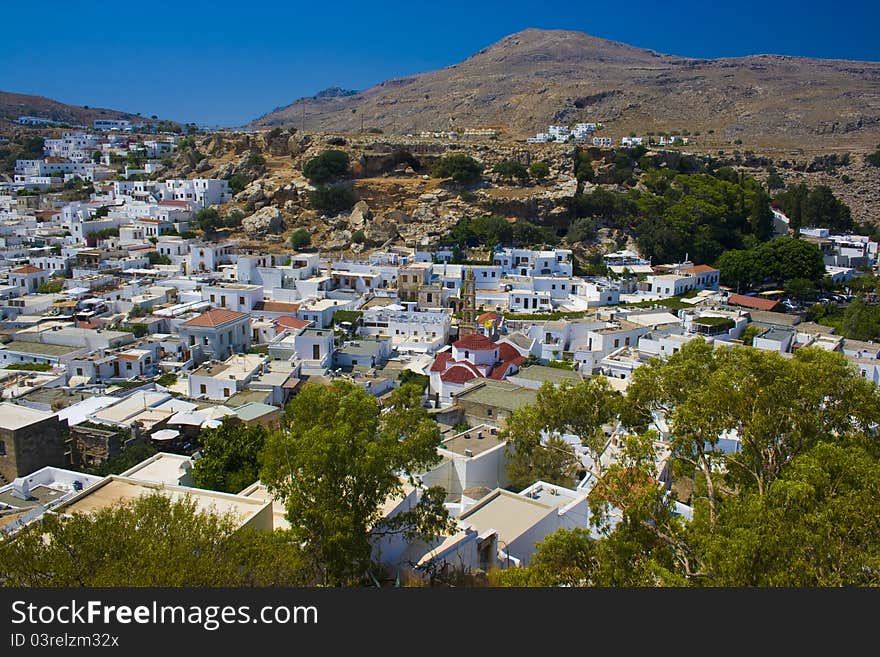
[0,494,313,587]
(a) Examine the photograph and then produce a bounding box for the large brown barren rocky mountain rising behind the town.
[251,29,880,151]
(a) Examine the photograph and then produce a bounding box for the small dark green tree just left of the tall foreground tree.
[193,419,267,493]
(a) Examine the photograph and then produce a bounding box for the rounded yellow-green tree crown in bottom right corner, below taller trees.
[689,442,880,587]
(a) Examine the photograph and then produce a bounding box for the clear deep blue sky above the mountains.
[0,0,880,126]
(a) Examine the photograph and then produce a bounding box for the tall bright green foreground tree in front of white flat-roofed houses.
[261,381,448,585]
